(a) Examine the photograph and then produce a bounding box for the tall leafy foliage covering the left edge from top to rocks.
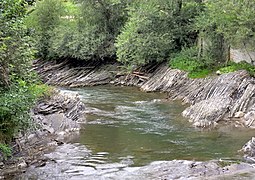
[0,0,49,143]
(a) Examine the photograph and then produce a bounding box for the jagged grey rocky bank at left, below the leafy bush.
[0,90,85,179]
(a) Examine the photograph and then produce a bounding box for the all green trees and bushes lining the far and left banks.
[0,0,255,175]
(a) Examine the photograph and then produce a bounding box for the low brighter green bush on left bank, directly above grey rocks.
[0,80,47,141]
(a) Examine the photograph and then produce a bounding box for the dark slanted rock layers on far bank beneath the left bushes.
[34,60,117,87]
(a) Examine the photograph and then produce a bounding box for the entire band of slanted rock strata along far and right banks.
[35,60,255,128]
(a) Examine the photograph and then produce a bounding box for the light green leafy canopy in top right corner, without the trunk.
[196,0,255,47]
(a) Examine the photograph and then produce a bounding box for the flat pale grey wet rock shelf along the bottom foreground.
[16,144,255,180]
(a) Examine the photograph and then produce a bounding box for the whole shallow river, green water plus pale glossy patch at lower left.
[19,86,253,179]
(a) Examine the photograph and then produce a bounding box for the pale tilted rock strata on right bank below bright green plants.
[141,68,255,128]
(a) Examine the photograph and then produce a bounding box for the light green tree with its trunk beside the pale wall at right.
[196,0,255,61]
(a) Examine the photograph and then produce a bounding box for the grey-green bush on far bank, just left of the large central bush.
[58,0,126,60]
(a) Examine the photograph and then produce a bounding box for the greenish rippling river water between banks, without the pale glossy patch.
[63,86,253,166]
